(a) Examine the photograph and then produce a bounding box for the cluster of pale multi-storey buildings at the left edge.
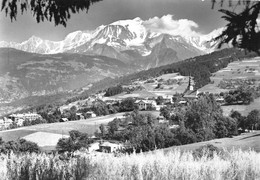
[0,113,42,129]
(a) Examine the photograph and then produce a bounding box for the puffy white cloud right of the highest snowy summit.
[143,14,200,37]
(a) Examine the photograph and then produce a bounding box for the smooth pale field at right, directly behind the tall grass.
[162,131,260,153]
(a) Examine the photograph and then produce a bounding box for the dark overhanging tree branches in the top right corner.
[212,0,260,54]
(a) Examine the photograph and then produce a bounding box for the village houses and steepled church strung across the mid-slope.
[0,74,204,130]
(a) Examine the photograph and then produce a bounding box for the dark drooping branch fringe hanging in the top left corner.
[2,0,101,26]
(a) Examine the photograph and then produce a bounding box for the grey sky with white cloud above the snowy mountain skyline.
[0,0,226,42]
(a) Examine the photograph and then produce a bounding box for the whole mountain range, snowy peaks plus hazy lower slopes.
[0,18,222,102]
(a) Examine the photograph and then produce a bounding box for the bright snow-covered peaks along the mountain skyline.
[0,17,222,55]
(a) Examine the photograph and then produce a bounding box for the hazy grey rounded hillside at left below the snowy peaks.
[0,48,136,103]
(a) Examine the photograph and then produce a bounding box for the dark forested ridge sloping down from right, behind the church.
[80,49,256,97]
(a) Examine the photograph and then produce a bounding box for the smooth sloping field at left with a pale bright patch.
[0,113,124,150]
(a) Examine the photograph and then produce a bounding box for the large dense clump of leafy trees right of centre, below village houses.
[100,94,240,152]
